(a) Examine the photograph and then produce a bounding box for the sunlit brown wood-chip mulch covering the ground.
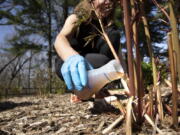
[0,91,180,135]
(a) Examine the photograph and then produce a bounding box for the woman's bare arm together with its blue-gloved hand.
[54,14,93,90]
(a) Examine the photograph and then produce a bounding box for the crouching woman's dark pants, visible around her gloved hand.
[55,53,111,80]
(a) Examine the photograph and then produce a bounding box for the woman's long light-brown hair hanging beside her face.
[74,0,115,23]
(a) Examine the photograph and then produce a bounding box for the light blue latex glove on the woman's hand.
[61,55,93,91]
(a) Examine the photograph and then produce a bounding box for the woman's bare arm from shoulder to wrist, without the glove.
[54,14,78,61]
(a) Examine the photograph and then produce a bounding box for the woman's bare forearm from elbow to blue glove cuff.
[54,34,78,60]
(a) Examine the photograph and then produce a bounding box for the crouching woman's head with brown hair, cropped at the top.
[75,0,115,24]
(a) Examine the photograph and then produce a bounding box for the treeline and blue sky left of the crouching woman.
[0,0,77,95]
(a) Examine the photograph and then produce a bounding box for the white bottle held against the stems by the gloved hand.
[74,60,124,100]
